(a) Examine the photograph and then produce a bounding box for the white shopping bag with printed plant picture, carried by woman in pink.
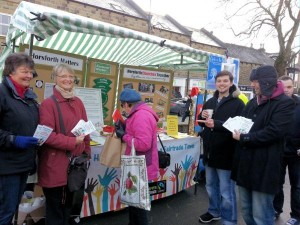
[120,139,151,211]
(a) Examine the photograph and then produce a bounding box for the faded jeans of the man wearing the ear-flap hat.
[239,186,275,225]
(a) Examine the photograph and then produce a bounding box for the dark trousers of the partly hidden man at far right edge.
[273,156,300,220]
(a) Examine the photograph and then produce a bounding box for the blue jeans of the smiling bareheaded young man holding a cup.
[205,166,237,225]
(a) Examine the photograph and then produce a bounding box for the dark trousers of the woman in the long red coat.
[43,186,83,225]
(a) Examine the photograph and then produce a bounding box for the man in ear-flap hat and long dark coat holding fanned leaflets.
[232,66,294,225]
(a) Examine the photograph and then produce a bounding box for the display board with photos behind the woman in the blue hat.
[118,65,174,121]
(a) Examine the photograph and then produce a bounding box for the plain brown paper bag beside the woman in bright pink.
[100,133,126,167]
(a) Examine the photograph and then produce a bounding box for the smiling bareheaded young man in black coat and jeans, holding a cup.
[198,70,244,225]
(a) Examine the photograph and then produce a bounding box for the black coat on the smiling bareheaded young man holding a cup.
[198,85,245,170]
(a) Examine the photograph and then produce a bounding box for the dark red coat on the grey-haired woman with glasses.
[38,88,91,188]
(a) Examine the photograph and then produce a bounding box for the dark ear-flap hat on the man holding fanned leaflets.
[250,66,278,97]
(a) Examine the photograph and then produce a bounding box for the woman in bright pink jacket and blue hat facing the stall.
[116,88,158,225]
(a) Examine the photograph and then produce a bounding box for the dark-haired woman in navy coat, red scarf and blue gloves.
[0,53,39,225]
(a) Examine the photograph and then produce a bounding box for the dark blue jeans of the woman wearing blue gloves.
[0,173,28,225]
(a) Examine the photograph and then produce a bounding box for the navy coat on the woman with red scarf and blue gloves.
[0,77,39,175]
